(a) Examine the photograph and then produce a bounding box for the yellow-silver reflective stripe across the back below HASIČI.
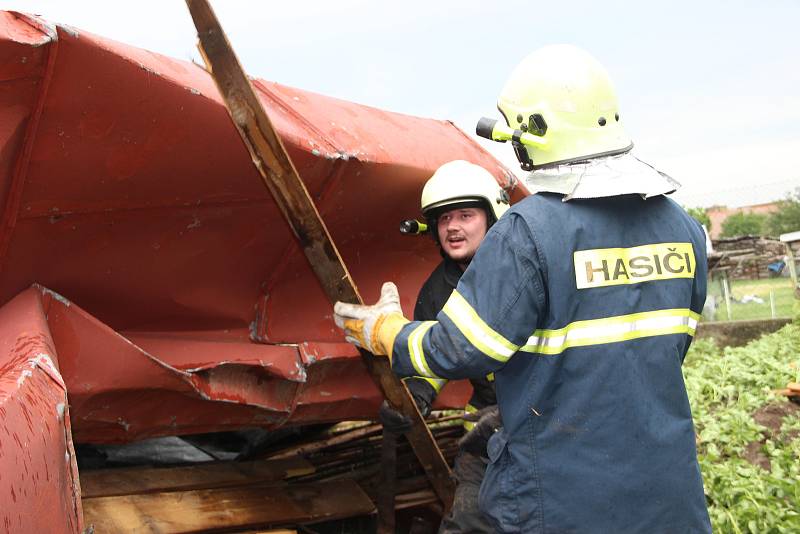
[519,308,700,354]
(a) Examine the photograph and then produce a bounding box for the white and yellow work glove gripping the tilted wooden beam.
[333,282,408,359]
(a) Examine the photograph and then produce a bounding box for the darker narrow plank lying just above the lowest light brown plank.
[80,457,314,499]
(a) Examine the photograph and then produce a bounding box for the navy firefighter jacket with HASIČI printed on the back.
[392,193,711,534]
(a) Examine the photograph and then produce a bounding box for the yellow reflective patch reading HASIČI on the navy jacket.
[573,243,697,289]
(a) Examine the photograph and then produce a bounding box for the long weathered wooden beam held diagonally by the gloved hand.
[186,0,454,508]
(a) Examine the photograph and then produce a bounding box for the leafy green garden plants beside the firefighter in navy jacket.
[683,322,800,534]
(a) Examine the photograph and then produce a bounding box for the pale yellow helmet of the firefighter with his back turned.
[478,45,633,170]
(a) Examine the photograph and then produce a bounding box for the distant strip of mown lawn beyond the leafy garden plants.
[706,278,795,321]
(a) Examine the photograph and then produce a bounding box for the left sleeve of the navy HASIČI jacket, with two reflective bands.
[392,213,546,379]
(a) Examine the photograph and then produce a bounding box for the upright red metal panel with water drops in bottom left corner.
[0,282,83,533]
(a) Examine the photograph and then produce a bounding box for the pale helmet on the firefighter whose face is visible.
[420,160,509,225]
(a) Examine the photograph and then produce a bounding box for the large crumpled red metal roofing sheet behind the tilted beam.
[0,12,523,450]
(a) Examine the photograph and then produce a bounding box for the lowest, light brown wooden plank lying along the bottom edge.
[83,480,375,534]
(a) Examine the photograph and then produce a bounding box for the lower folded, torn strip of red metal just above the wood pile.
[2,286,462,443]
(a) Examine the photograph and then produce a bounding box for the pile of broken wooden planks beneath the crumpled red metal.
[80,416,463,534]
